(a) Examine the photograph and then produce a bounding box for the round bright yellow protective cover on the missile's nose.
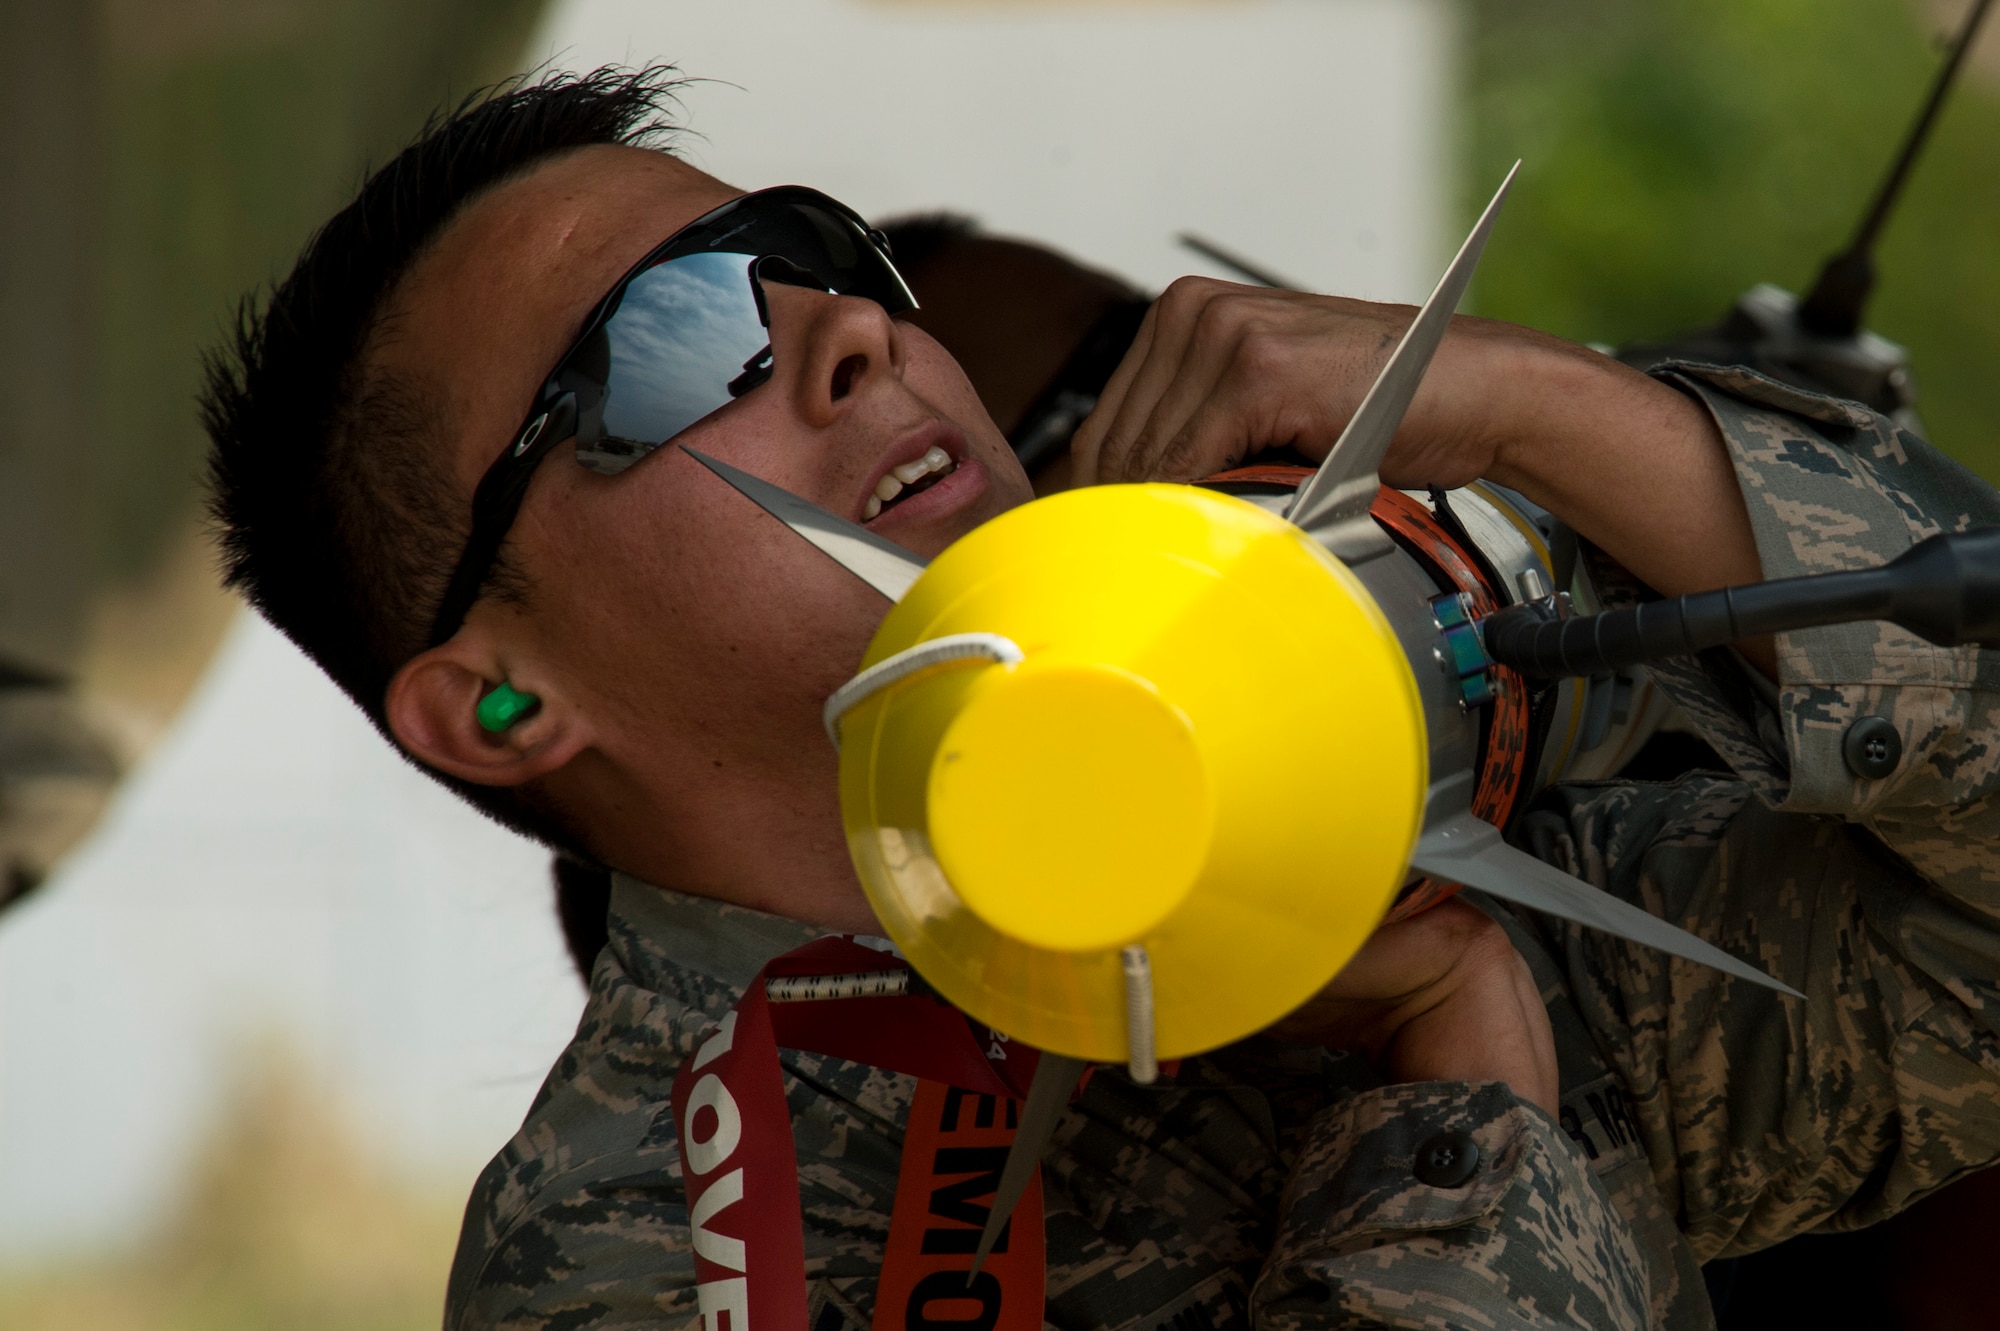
[840,486,1428,1061]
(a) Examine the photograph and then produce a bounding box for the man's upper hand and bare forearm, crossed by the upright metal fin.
[1070,278,1774,673]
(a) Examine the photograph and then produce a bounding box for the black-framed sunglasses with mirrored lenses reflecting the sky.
[430,186,916,648]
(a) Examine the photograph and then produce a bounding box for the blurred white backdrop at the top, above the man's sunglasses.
[532,0,1456,300]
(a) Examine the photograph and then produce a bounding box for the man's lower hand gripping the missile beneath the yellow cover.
[1270,901,1558,1113]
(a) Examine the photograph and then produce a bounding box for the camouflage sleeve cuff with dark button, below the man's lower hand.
[1252,1081,1652,1331]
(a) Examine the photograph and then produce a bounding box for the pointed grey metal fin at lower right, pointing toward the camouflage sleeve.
[1410,813,1804,997]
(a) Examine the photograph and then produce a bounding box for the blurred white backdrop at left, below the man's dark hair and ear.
[0,614,582,1261]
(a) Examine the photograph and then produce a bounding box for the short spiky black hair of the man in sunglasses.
[200,66,680,843]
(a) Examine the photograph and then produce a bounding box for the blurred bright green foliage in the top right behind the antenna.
[1464,0,2000,478]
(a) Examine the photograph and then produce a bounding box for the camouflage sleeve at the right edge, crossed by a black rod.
[1520,357,2000,1259]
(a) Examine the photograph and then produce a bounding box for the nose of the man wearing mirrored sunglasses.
[764,282,904,426]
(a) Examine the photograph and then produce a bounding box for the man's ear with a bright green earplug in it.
[384,634,592,785]
